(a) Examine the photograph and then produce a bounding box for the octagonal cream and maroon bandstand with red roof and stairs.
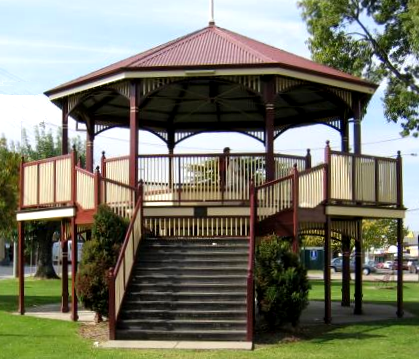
[17,22,405,342]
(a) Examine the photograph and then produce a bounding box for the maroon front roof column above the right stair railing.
[262,76,275,181]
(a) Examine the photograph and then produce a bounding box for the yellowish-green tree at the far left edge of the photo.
[0,137,20,242]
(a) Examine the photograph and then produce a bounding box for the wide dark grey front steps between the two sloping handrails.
[116,238,249,341]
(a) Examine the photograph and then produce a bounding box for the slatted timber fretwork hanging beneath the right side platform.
[299,220,358,240]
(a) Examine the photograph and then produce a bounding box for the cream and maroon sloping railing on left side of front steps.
[108,181,144,340]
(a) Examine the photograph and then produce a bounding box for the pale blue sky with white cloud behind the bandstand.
[0,0,419,230]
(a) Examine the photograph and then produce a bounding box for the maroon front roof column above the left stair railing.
[129,82,139,188]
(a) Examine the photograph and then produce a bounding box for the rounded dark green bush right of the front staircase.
[255,235,310,329]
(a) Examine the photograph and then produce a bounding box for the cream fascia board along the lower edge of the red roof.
[49,67,376,101]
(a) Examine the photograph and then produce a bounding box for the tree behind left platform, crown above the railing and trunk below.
[20,123,84,278]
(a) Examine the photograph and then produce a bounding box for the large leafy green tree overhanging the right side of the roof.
[298,0,419,136]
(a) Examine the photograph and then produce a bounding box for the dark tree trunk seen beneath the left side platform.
[35,222,59,279]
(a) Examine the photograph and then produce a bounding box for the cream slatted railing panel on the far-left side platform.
[21,154,73,208]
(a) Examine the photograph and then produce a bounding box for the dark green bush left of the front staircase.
[76,205,128,318]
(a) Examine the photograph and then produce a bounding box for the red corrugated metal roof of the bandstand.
[46,25,374,94]
